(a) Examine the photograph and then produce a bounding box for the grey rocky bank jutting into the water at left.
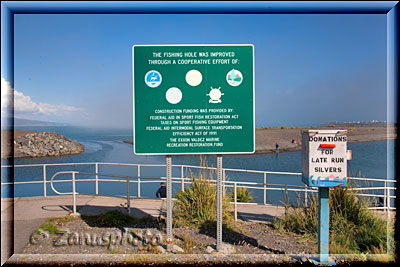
[2,132,85,158]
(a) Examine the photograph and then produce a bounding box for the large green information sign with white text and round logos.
[132,45,255,155]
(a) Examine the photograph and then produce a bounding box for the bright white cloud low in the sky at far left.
[1,78,84,116]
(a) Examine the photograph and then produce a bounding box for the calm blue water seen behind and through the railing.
[1,126,395,207]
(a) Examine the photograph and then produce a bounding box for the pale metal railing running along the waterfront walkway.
[1,162,396,222]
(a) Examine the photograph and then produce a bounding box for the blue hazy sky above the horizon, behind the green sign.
[1,14,387,128]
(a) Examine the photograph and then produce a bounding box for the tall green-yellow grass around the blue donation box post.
[274,186,393,254]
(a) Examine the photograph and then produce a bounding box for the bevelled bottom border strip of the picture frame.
[6,253,394,265]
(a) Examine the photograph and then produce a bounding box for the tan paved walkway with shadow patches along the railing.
[1,195,285,264]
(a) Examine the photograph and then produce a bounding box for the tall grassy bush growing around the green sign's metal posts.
[173,160,232,227]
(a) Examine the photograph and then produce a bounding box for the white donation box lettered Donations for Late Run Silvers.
[301,130,347,187]
